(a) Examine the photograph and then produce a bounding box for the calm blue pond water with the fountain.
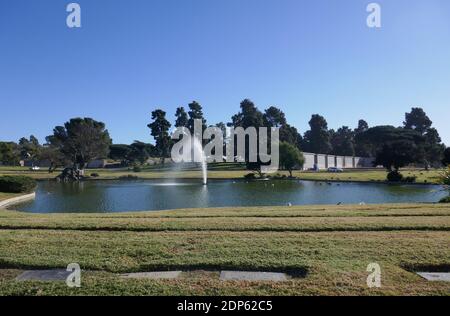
[14,180,446,213]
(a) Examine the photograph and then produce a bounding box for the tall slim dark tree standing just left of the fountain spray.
[147,109,171,164]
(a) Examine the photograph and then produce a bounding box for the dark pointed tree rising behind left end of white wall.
[303,114,331,154]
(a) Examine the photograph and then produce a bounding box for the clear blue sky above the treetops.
[0,0,450,144]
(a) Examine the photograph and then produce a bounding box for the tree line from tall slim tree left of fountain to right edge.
[148,99,449,170]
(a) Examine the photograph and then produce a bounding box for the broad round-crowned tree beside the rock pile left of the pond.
[47,118,112,170]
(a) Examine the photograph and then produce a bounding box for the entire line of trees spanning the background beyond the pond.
[0,99,450,175]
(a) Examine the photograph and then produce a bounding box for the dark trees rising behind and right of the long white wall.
[301,108,445,167]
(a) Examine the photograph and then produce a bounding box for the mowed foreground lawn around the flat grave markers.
[0,204,450,295]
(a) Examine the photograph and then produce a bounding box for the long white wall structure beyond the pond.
[303,153,375,169]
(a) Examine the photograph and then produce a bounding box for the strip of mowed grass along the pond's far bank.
[0,163,441,184]
